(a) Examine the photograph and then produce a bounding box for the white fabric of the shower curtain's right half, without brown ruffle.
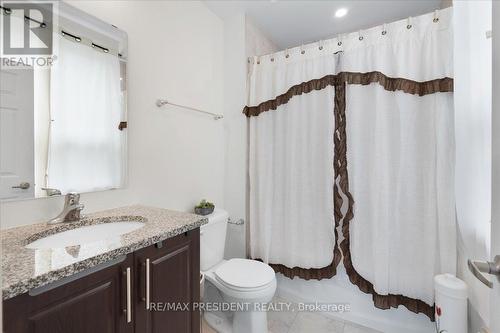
[342,9,456,305]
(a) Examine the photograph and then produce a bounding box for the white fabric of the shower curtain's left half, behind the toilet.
[249,50,336,275]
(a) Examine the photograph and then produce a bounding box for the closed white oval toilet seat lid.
[214,259,276,291]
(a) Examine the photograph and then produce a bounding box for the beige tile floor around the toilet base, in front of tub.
[202,299,382,333]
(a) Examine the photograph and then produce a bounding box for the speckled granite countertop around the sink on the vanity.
[0,205,208,300]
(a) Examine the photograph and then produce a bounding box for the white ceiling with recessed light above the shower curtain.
[205,0,443,49]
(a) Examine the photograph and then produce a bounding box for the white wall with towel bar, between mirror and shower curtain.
[0,1,225,228]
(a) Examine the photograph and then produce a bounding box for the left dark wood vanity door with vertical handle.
[3,255,134,333]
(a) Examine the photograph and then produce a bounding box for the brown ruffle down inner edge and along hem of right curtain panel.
[335,83,434,321]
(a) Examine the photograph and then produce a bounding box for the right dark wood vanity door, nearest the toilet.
[135,229,200,333]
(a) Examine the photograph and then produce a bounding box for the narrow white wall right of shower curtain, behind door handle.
[453,1,492,332]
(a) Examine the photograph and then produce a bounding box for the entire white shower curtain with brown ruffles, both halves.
[244,9,456,319]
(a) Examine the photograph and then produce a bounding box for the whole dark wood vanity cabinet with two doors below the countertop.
[3,229,200,333]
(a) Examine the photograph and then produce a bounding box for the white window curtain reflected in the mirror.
[47,35,124,193]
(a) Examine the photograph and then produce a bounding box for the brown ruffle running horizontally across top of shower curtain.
[243,71,453,117]
